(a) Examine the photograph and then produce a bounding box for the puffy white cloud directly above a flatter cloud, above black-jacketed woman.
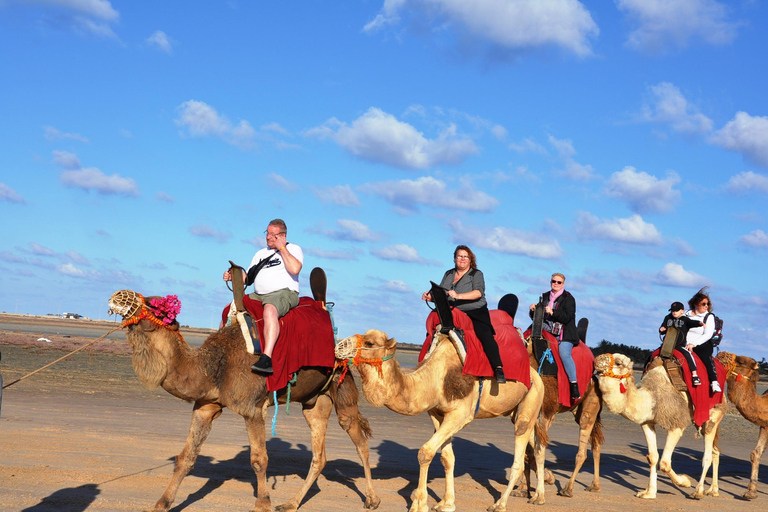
[605,166,680,213]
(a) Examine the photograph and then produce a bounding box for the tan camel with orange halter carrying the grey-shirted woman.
[336,329,546,512]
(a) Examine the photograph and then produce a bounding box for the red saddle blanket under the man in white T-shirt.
[221,295,336,392]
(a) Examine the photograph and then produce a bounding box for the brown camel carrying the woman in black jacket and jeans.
[521,343,604,498]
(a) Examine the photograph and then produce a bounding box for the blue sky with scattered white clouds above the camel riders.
[0,0,768,360]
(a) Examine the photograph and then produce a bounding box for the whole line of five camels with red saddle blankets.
[109,262,768,512]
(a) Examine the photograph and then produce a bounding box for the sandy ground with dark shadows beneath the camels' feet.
[0,324,768,512]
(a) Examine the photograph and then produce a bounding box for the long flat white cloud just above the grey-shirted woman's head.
[449,221,563,259]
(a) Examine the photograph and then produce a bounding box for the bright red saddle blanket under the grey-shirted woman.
[419,308,531,388]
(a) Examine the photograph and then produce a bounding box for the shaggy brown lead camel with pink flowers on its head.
[110,290,381,512]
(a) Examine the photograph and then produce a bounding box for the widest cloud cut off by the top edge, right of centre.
[363,0,599,56]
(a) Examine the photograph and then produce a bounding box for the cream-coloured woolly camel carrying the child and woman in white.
[595,354,728,499]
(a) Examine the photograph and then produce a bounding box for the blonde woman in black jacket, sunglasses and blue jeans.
[530,272,581,400]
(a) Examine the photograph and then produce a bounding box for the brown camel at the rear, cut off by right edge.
[717,352,768,500]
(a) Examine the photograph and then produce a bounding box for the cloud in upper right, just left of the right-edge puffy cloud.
[640,82,712,134]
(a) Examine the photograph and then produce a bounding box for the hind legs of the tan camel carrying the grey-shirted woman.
[487,404,546,512]
